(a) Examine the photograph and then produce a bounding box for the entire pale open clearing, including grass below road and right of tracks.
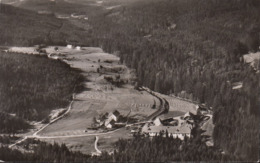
[7,47,195,153]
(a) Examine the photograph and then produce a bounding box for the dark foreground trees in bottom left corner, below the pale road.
[0,140,90,163]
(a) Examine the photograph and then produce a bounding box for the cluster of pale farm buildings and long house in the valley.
[91,106,212,140]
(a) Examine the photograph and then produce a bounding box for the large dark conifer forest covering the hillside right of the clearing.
[87,0,260,160]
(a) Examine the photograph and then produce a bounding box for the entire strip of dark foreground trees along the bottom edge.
[0,133,235,163]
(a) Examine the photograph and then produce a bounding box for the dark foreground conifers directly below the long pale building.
[91,133,239,162]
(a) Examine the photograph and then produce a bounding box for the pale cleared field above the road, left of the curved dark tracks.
[34,47,159,136]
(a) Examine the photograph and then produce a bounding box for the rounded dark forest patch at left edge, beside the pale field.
[0,52,84,133]
